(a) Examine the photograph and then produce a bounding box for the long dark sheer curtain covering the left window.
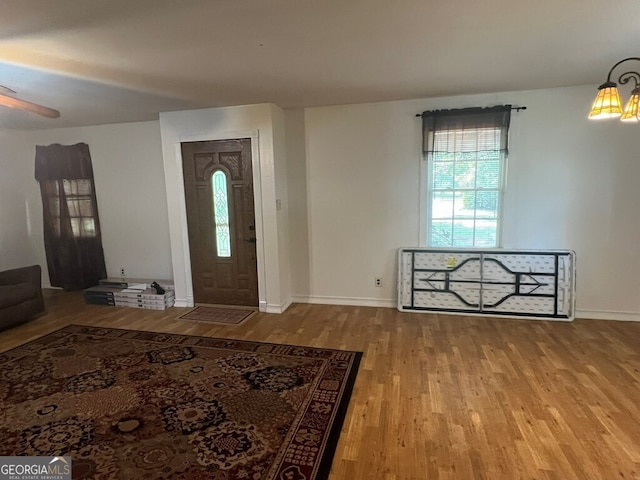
[35,143,106,290]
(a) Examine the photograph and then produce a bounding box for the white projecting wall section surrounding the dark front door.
[160,104,291,313]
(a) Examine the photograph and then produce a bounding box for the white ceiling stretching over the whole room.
[0,0,640,129]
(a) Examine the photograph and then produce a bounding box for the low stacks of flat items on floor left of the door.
[84,279,176,310]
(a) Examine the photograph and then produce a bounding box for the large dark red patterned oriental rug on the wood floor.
[0,325,362,480]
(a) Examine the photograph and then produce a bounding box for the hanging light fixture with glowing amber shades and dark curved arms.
[589,57,640,122]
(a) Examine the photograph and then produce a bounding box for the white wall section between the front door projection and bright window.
[296,102,420,306]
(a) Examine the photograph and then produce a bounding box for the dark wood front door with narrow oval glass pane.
[181,138,258,306]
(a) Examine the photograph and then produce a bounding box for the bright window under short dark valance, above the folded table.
[422,105,511,248]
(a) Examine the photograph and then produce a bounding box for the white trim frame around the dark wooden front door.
[173,129,267,312]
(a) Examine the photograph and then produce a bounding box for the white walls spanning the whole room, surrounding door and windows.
[0,86,640,320]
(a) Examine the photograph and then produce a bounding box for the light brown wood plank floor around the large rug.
[0,293,640,480]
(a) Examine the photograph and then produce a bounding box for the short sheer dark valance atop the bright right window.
[422,105,511,153]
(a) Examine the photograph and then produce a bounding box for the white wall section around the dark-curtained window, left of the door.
[0,122,172,285]
